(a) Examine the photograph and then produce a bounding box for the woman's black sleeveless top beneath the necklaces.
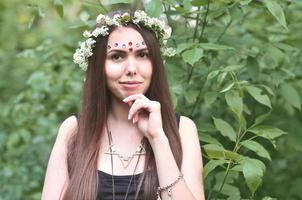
[75,113,180,200]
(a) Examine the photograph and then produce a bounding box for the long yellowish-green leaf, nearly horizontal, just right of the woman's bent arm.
[203,144,241,161]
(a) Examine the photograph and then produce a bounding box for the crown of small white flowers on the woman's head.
[73,10,175,71]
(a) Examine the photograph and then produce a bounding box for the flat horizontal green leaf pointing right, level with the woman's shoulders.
[248,125,286,140]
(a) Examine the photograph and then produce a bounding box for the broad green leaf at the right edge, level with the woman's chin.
[281,83,301,110]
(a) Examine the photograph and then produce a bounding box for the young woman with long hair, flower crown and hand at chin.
[42,11,204,200]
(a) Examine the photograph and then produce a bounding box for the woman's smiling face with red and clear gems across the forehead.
[105,27,152,99]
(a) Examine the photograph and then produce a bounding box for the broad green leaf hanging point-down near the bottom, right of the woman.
[241,159,265,195]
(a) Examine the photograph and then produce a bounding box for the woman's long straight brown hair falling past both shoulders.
[63,13,182,200]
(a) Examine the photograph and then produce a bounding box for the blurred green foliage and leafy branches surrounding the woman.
[0,0,302,200]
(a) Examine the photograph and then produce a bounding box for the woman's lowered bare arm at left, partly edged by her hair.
[41,116,77,200]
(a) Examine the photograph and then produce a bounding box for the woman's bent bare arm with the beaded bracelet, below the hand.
[150,116,205,200]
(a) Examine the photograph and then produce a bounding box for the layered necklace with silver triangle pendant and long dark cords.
[105,120,146,200]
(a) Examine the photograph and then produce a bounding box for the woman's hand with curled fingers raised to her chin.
[123,94,165,141]
